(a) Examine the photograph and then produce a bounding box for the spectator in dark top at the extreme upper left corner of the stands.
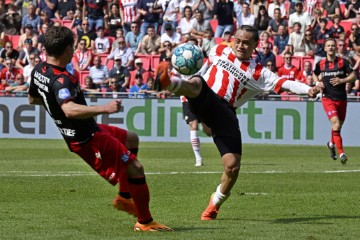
[0,4,22,35]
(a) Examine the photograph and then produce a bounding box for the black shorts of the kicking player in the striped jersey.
[187,76,242,156]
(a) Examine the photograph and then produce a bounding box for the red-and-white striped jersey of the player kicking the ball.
[200,45,285,108]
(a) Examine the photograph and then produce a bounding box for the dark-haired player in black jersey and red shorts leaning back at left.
[29,27,172,231]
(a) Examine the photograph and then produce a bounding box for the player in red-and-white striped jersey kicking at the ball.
[154,25,320,220]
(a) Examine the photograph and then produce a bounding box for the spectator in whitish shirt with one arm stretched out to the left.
[105,37,134,71]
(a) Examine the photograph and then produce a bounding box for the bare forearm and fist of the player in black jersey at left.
[61,100,121,119]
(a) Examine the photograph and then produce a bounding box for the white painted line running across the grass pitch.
[0,169,360,177]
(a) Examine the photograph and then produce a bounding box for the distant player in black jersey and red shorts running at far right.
[313,38,356,164]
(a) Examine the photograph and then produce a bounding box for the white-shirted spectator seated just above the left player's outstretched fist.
[89,56,109,89]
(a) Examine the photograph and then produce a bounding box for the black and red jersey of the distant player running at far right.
[314,57,353,100]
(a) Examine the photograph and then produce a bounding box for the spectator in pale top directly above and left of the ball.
[140,25,161,55]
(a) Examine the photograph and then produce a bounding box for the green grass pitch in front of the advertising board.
[0,139,360,240]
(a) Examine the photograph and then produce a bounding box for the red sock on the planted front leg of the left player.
[128,177,152,223]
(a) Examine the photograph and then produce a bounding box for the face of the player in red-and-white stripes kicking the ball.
[233,30,258,60]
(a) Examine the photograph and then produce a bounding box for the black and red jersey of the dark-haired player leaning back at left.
[29,62,99,143]
